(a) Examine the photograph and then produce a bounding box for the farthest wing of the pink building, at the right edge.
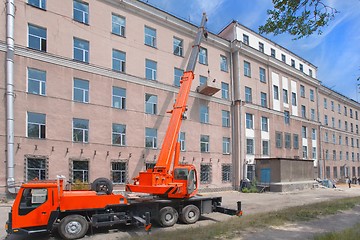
[319,86,360,179]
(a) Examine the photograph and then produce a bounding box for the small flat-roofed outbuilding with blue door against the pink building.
[255,158,316,192]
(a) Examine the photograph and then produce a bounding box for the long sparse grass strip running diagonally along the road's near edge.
[131,197,360,240]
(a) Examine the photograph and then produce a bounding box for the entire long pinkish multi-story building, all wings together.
[0,0,360,195]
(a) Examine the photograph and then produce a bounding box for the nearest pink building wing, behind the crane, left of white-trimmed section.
[0,0,232,193]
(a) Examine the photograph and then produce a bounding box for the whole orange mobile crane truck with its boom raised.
[5,13,242,239]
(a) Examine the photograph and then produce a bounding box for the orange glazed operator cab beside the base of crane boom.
[174,165,198,196]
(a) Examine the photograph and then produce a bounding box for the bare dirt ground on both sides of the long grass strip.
[0,185,360,240]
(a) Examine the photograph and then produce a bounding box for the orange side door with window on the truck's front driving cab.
[13,188,56,228]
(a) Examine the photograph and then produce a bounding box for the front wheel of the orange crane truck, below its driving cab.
[58,215,89,239]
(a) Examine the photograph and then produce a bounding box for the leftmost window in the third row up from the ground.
[28,68,46,95]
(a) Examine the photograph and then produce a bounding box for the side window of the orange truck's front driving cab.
[19,188,48,215]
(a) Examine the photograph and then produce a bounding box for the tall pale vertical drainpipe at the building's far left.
[5,0,16,193]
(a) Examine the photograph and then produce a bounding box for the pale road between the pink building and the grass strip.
[0,185,360,240]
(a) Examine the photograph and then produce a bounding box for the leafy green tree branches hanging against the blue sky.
[259,0,338,39]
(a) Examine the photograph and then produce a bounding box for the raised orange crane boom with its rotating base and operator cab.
[126,13,207,198]
